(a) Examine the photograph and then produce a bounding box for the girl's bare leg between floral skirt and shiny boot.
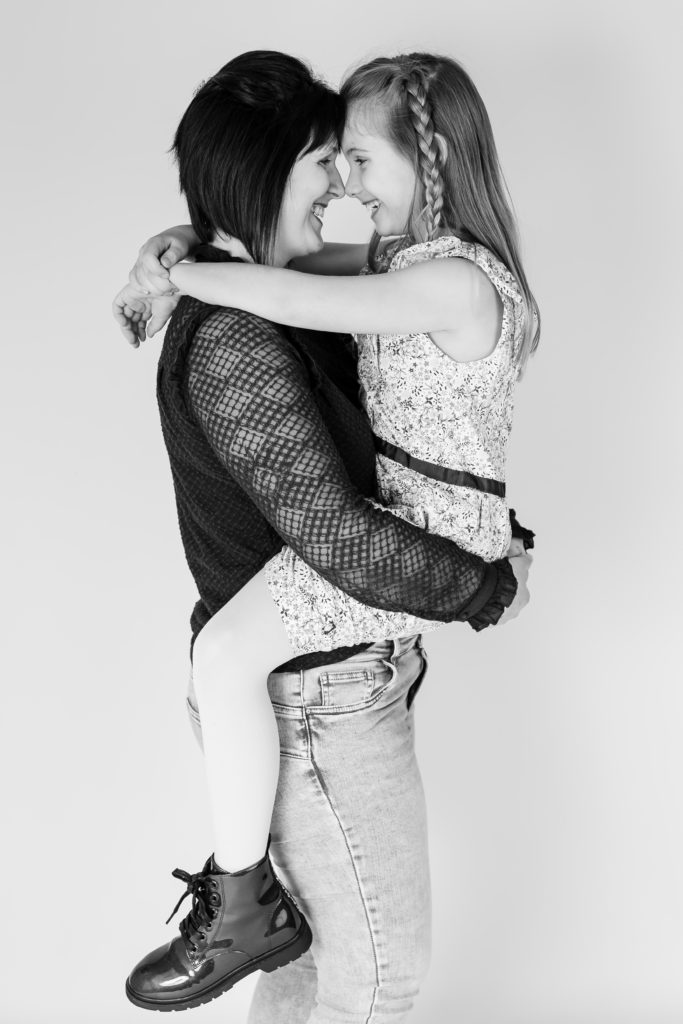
[193,569,292,871]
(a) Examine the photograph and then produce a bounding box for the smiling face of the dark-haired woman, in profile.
[272,141,344,266]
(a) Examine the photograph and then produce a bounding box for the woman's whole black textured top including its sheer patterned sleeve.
[158,247,516,669]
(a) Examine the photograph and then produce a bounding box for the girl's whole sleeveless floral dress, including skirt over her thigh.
[266,236,524,653]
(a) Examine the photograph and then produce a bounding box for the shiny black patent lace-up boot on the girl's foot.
[126,853,311,1010]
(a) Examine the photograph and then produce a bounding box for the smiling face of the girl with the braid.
[342,102,417,234]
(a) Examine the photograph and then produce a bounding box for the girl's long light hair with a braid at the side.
[341,53,541,368]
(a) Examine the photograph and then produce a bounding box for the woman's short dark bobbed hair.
[173,50,344,263]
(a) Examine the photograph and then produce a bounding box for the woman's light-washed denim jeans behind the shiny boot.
[190,637,430,1024]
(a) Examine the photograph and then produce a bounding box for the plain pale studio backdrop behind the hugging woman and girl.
[0,0,683,1024]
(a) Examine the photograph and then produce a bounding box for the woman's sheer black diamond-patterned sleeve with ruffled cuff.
[187,309,514,629]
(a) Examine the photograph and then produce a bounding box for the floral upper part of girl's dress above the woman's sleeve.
[356,236,523,561]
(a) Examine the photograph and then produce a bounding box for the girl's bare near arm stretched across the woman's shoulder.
[171,259,478,334]
